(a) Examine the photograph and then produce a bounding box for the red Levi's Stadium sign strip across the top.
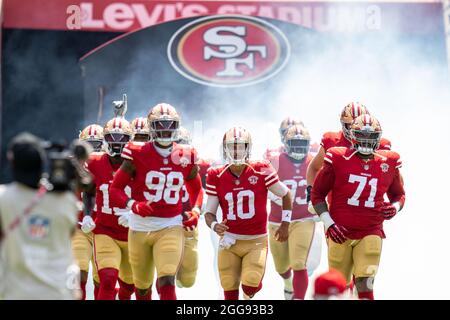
[3,0,442,33]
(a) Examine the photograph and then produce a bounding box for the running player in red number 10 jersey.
[205,127,292,300]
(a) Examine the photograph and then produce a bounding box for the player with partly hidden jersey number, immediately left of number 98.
[82,117,134,300]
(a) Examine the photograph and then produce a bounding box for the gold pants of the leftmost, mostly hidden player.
[72,229,100,283]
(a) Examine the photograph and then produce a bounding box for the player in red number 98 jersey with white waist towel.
[111,103,203,300]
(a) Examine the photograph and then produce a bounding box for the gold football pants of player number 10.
[218,236,267,291]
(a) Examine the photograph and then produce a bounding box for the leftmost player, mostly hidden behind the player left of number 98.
[72,124,103,300]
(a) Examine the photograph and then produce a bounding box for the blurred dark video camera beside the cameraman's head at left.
[43,140,92,191]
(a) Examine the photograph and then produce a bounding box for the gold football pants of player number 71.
[328,235,382,284]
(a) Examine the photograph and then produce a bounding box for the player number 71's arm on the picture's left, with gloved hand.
[311,162,347,243]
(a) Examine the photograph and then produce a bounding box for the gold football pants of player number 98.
[128,226,184,289]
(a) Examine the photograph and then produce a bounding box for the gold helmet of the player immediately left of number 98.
[103,117,133,157]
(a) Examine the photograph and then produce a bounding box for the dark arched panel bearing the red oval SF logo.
[80,15,316,122]
